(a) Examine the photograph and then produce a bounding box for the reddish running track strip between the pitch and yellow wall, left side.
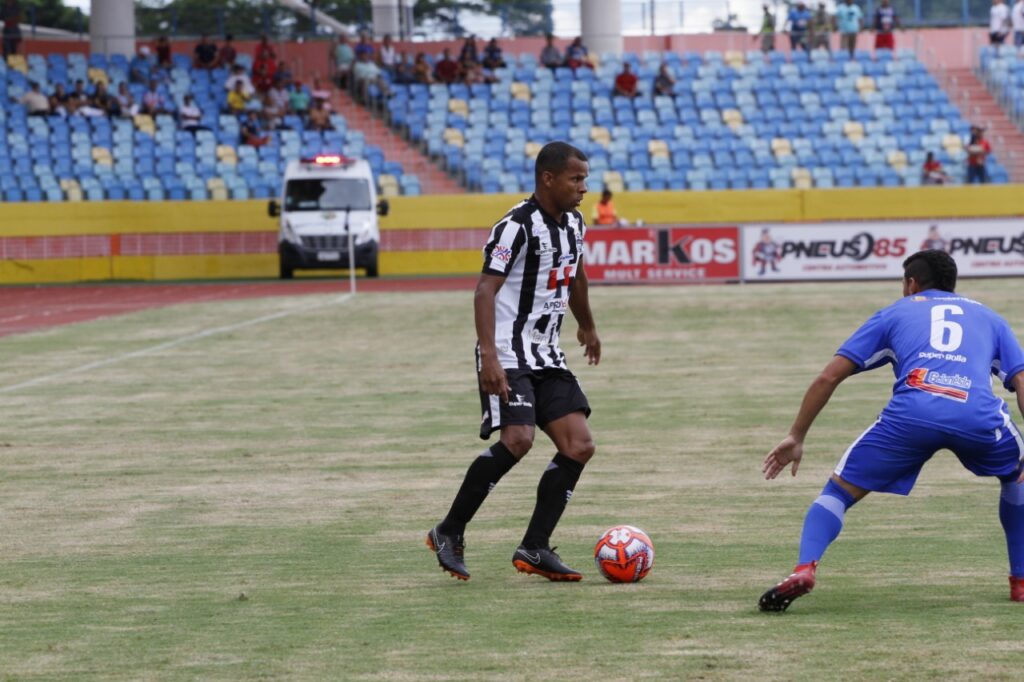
[0,278,475,336]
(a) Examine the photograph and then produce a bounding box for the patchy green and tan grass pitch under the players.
[0,280,1024,680]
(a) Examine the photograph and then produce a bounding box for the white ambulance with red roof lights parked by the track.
[267,155,388,280]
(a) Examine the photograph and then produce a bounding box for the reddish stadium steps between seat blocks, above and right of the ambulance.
[333,90,466,195]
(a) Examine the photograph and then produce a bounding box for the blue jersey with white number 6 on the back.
[837,289,1024,439]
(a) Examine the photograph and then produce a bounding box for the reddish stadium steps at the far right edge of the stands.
[940,69,1024,182]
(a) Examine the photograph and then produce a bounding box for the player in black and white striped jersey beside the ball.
[427,142,601,581]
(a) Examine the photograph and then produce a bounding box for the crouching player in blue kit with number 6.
[758,251,1024,611]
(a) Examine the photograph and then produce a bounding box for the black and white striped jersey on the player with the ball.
[483,197,587,370]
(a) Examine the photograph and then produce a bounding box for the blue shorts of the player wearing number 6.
[836,419,1024,495]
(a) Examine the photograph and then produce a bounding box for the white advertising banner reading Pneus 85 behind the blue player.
[743,218,1024,282]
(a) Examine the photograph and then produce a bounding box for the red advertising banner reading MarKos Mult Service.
[584,226,740,284]
